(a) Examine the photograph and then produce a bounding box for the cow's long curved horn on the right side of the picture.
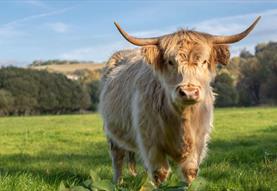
[211,16,261,44]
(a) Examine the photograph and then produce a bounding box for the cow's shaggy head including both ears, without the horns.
[142,34,230,108]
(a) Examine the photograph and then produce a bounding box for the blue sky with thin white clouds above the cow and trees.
[0,0,277,66]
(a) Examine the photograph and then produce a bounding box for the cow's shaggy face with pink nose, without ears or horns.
[156,40,213,107]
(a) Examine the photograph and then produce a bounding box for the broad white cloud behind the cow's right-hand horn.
[192,9,277,56]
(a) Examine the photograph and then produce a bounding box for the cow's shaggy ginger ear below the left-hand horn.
[141,45,163,69]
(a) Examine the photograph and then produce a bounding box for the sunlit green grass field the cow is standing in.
[0,108,277,191]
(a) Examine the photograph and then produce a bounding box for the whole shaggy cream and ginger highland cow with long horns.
[100,17,260,185]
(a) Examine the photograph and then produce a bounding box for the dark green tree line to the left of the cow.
[0,67,98,116]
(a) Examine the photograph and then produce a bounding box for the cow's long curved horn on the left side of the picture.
[114,22,159,46]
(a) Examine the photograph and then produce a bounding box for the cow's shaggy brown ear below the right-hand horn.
[213,44,230,65]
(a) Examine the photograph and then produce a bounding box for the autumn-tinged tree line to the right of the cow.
[213,42,277,107]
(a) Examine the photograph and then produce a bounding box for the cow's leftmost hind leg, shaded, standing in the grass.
[110,140,126,183]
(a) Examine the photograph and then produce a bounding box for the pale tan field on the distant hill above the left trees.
[31,64,104,73]
